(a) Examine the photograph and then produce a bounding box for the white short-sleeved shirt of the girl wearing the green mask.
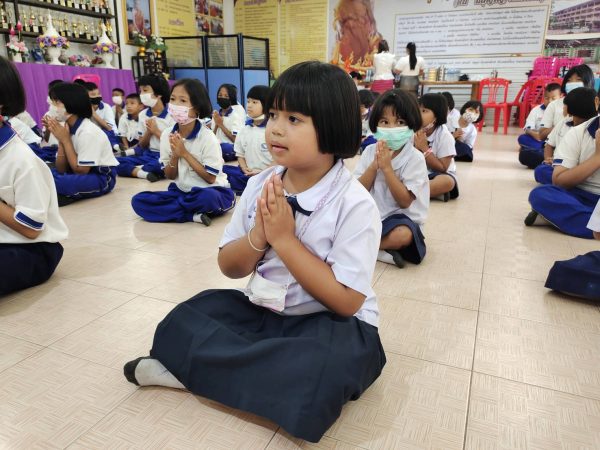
[354,142,429,229]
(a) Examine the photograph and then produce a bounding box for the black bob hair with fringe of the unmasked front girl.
[266,61,362,158]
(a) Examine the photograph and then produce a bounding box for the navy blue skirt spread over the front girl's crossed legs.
[150,290,386,442]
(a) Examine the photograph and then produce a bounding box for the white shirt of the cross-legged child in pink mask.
[160,120,229,192]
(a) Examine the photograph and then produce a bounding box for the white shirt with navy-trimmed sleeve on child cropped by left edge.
[0,125,69,244]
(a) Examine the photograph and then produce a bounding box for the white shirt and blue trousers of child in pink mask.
[131,120,235,222]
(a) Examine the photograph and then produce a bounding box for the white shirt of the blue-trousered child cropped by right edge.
[552,117,600,195]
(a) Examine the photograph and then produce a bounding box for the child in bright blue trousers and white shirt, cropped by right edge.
[525,110,600,239]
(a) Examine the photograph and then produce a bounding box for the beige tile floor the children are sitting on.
[0,130,600,450]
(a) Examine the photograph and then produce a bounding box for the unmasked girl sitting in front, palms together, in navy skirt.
[124,62,385,442]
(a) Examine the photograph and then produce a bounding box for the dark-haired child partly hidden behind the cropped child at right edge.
[533,88,598,184]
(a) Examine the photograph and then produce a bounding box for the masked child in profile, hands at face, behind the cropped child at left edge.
[44,83,118,206]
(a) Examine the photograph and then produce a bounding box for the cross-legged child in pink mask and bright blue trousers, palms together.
[131,78,235,226]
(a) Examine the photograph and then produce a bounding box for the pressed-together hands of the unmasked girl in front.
[260,175,296,249]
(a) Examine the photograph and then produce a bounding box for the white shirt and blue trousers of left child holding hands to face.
[52,118,119,200]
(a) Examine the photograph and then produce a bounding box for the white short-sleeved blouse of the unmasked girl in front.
[219,160,381,326]
